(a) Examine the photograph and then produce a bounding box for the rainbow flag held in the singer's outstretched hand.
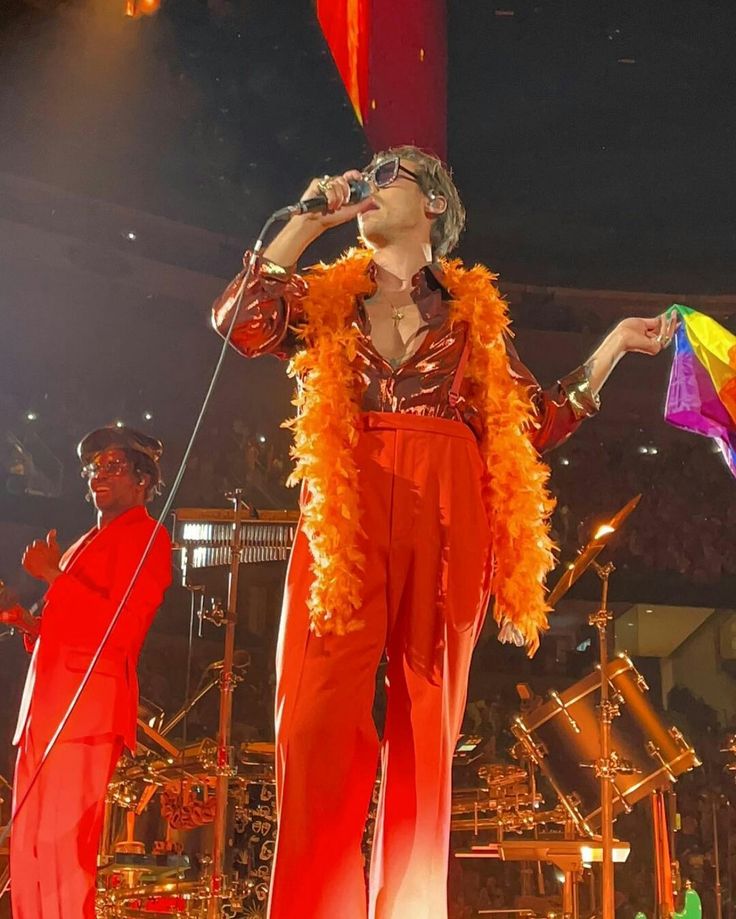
[664,303,736,477]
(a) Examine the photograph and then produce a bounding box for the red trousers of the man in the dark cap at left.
[10,729,123,919]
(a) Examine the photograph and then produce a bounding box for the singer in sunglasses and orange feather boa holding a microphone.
[213,147,673,919]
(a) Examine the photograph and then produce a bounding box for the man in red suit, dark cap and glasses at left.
[3,427,171,919]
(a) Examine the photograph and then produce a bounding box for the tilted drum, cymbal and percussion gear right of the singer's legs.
[452,496,700,919]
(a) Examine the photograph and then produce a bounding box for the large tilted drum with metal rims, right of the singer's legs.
[512,655,700,835]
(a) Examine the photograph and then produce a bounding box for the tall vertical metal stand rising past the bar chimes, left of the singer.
[207,488,249,919]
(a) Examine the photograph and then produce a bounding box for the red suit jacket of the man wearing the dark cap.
[13,507,171,749]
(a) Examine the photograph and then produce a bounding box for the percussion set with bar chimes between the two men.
[97,500,298,919]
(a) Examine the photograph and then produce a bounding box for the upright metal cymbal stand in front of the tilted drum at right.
[588,562,619,919]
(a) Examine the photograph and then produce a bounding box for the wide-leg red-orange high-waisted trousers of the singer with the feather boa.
[269,413,489,919]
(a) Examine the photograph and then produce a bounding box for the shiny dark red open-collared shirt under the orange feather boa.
[212,253,597,452]
